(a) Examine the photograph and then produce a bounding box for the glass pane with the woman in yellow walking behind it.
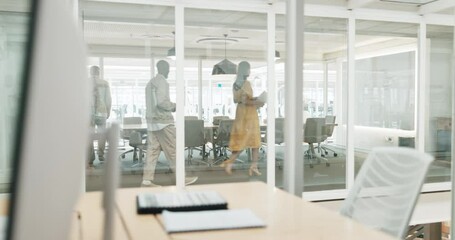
[184,8,267,184]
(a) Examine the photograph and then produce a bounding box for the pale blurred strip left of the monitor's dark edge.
[0,1,31,193]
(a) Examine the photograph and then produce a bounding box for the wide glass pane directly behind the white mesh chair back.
[354,20,418,173]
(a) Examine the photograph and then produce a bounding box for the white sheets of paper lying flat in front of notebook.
[163,209,265,233]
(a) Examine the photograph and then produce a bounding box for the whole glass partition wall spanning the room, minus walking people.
[79,1,453,199]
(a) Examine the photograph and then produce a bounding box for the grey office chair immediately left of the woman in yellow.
[212,119,237,164]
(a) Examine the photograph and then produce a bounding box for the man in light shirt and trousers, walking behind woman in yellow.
[142,60,198,187]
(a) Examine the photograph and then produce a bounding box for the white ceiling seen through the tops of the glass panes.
[81,0,440,62]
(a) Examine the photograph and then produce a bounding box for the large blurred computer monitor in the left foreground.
[7,0,91,240]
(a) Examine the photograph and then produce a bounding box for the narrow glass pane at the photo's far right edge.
[425,25,454,182]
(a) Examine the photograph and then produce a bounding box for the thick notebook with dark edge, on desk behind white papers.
[136,191,227,214]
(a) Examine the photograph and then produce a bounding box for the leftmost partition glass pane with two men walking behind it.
[80,1,176,190]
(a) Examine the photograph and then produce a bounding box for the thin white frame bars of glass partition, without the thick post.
[82,0,455,200]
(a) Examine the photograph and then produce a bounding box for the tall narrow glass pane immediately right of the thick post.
[303,17,347,192]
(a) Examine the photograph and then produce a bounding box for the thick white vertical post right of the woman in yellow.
[284,0,304,197]
